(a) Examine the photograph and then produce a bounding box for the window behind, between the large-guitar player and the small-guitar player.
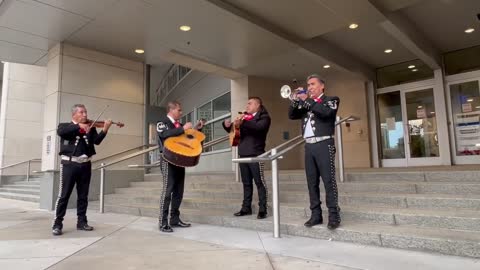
[197,92,231,152]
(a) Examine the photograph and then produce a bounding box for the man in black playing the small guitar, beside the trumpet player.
[223,97,270,219]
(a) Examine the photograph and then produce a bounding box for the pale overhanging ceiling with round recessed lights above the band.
[0,0,480,79]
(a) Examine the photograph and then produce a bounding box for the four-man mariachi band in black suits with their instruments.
[52,74,341,235]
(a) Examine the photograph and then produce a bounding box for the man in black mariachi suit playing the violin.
[52,104,112,235]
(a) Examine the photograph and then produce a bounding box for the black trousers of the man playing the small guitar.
[240,159,268,212]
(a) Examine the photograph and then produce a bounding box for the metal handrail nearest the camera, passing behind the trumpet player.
[232,115,357,238]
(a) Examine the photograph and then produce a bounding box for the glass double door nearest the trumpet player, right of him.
[377,88,441,167]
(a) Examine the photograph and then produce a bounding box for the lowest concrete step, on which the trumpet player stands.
[91,202,480,258]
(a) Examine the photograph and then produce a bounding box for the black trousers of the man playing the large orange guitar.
[158,158,185,225]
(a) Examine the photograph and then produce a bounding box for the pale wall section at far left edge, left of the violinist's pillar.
[0,63,47,175]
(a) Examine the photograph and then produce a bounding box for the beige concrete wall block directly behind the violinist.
[42,44,145,170]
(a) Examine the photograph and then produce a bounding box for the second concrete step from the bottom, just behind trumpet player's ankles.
[105,195,480,231]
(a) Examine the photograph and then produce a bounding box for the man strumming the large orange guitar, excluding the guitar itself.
[157,101,204,233]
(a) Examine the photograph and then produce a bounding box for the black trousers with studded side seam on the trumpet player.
[305,139,339,218]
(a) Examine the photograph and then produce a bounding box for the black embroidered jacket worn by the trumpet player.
[288,95,340,137]
